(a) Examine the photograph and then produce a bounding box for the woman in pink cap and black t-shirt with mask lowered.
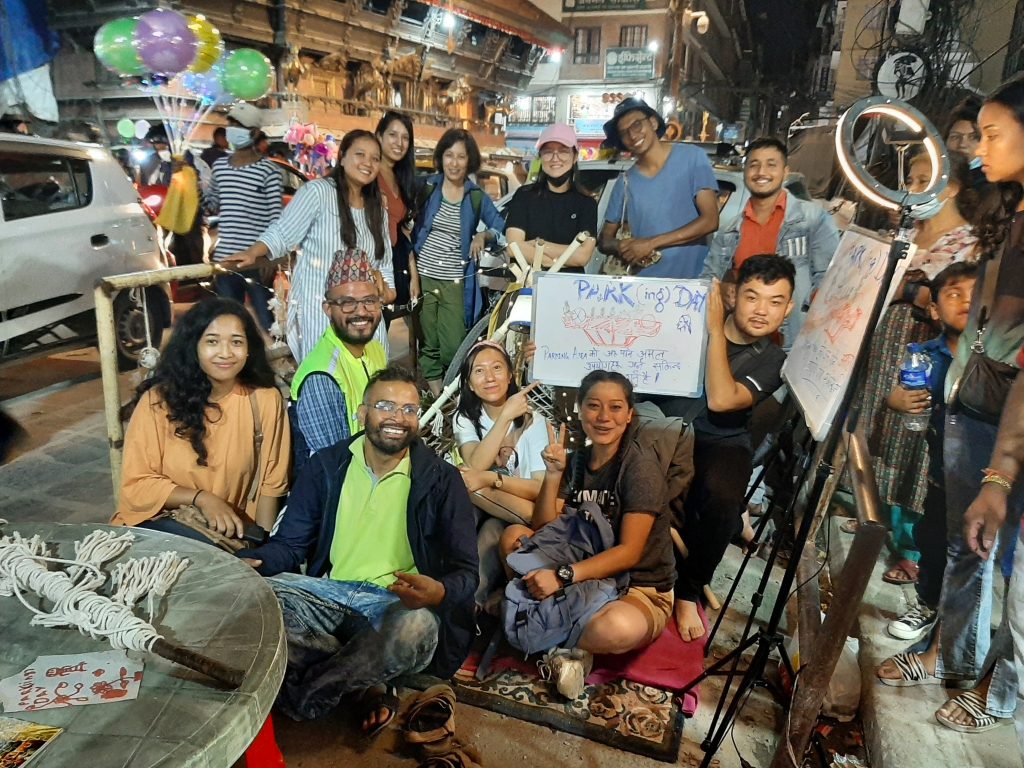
[505,123,597,272]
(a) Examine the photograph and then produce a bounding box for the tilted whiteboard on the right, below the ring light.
[782,227,914,440]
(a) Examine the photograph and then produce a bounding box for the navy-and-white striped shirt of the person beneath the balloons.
[205,157,282,261]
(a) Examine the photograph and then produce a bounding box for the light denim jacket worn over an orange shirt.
[700,193,839,351]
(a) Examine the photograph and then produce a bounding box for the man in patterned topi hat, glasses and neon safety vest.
[289,251,387,475]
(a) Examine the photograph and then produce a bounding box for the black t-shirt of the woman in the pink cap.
[505,183,597,273]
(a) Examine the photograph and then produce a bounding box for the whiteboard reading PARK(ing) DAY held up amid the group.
[530,272,711,397]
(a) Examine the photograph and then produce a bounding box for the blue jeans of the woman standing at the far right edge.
[935,414,1024,717]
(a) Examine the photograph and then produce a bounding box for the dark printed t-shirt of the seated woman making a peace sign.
[558,443,676,592]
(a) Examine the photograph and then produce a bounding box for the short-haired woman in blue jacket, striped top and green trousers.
[410,128,505,396]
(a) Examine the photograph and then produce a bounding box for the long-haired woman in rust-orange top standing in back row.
[375,110,416,324]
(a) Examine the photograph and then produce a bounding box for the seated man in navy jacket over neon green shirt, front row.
[239,367,478,733]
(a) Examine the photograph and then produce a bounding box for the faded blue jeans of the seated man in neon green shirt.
[268,573,440,720]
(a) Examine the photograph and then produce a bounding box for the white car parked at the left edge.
[0,133,171,366]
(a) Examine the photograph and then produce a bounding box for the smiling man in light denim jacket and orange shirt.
[700,137,839,351]
